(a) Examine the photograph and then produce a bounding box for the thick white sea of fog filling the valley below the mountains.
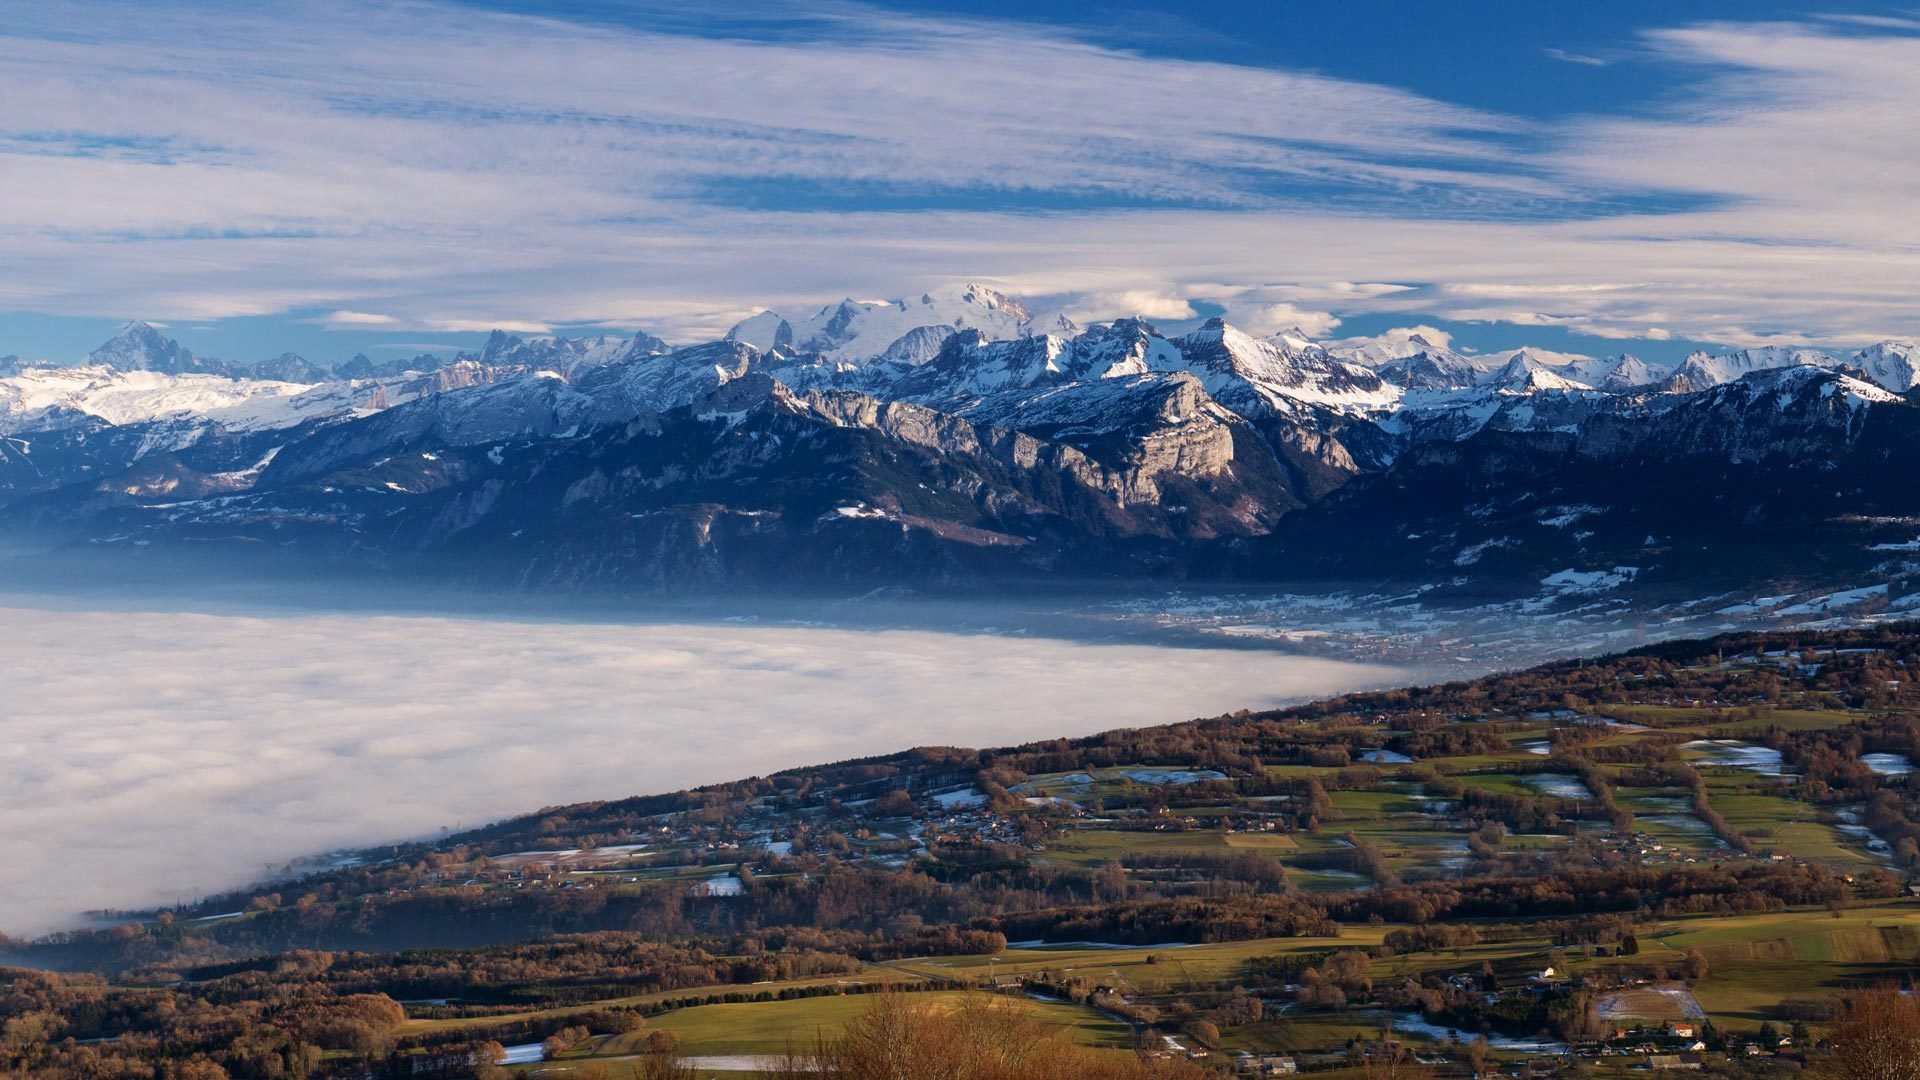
[0,600,1409,934]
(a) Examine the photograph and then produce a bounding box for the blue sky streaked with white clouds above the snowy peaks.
[0,0,1920,361]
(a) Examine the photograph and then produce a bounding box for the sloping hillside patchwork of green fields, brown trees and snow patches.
[18,628,1920,1080]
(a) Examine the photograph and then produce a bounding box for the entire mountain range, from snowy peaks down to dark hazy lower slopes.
[0,284,1920,605]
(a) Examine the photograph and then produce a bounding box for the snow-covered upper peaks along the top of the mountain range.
[22,303,1920,478]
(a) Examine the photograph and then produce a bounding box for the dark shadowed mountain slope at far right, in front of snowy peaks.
[1235,365,1920,596]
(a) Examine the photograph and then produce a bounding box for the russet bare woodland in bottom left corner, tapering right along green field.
[0,914,1006,1080]
